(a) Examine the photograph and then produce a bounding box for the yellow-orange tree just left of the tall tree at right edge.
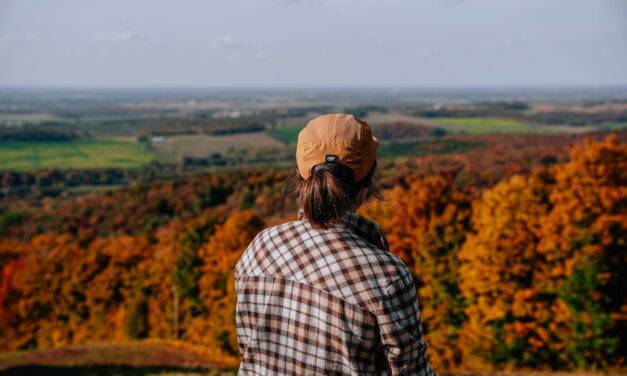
[459,176,547,369]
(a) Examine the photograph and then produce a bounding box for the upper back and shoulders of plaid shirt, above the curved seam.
[236,214,408,310]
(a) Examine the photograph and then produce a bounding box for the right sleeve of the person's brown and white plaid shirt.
[377,268,435,376]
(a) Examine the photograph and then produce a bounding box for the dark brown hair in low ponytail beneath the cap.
[291,163,382,229]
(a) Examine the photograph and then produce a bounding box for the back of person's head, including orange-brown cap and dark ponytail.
[294,114,379,229]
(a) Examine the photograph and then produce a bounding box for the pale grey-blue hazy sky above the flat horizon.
[0,0,627,88]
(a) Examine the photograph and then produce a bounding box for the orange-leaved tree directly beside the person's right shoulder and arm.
[360,176,470,369]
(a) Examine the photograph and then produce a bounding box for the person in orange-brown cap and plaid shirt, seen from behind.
[235,114,434,376]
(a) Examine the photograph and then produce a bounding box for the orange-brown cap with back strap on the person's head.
[296,114,379,182]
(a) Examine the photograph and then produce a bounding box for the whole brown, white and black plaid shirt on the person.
[235,213,434,376]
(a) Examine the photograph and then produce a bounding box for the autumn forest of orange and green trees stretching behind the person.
[0,119,627,370]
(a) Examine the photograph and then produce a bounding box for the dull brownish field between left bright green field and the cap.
[153,132,283,162]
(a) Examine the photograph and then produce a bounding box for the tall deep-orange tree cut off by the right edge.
[537,136,627,367]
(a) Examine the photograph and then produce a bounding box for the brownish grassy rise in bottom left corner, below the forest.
[0,343,236,376]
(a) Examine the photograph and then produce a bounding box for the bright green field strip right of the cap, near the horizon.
[433,117,539,133]
